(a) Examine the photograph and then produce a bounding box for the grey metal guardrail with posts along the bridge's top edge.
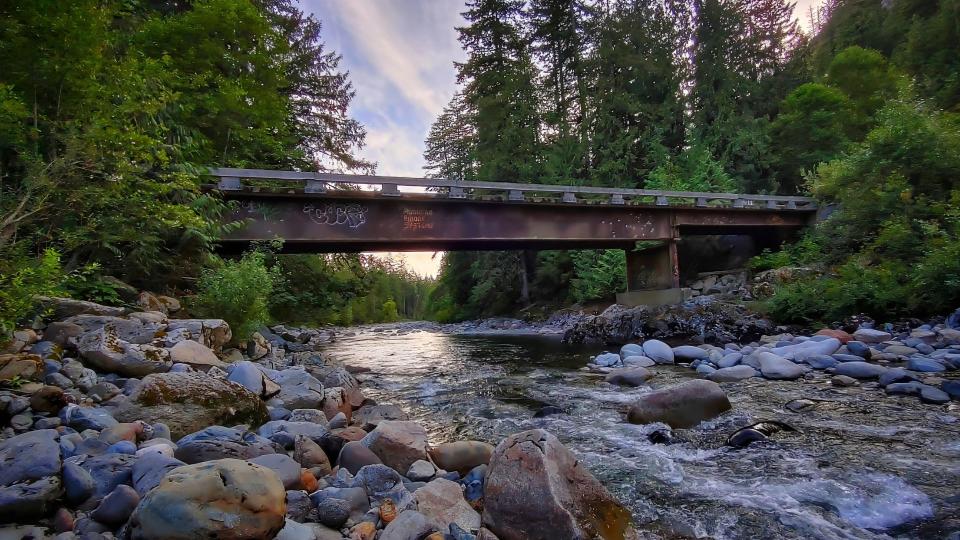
[210,168,817,210]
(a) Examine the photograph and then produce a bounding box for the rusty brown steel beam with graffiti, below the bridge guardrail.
[222,191,814,252]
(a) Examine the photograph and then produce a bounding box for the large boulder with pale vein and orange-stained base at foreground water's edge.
[484,429,631,540]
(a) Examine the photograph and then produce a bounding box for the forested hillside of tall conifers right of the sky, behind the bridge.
[425,0,960,320]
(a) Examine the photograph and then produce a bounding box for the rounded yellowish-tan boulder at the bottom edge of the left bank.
[130,459,286,540]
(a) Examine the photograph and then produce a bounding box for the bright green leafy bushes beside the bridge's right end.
[757,98,960,322]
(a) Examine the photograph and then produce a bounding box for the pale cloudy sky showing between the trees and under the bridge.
[300,0,822,276]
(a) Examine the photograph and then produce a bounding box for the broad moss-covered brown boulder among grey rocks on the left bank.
[115,372,268,438]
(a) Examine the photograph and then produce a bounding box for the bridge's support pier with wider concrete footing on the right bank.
[617,239,689,306]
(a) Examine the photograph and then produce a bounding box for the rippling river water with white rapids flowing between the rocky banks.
[325,327,960,539]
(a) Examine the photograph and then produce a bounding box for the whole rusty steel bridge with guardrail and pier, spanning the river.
[206,168,817,304]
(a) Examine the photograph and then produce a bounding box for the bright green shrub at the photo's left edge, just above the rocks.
[0,249,64,343]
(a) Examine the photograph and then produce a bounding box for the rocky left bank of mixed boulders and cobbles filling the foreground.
[0,294,635,540]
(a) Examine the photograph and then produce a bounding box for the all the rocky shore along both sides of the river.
[0,295,960,540]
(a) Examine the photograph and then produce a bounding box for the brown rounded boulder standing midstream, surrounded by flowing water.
[627,380,730,428]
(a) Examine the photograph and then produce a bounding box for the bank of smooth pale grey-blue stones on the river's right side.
[583,324,960,418]
